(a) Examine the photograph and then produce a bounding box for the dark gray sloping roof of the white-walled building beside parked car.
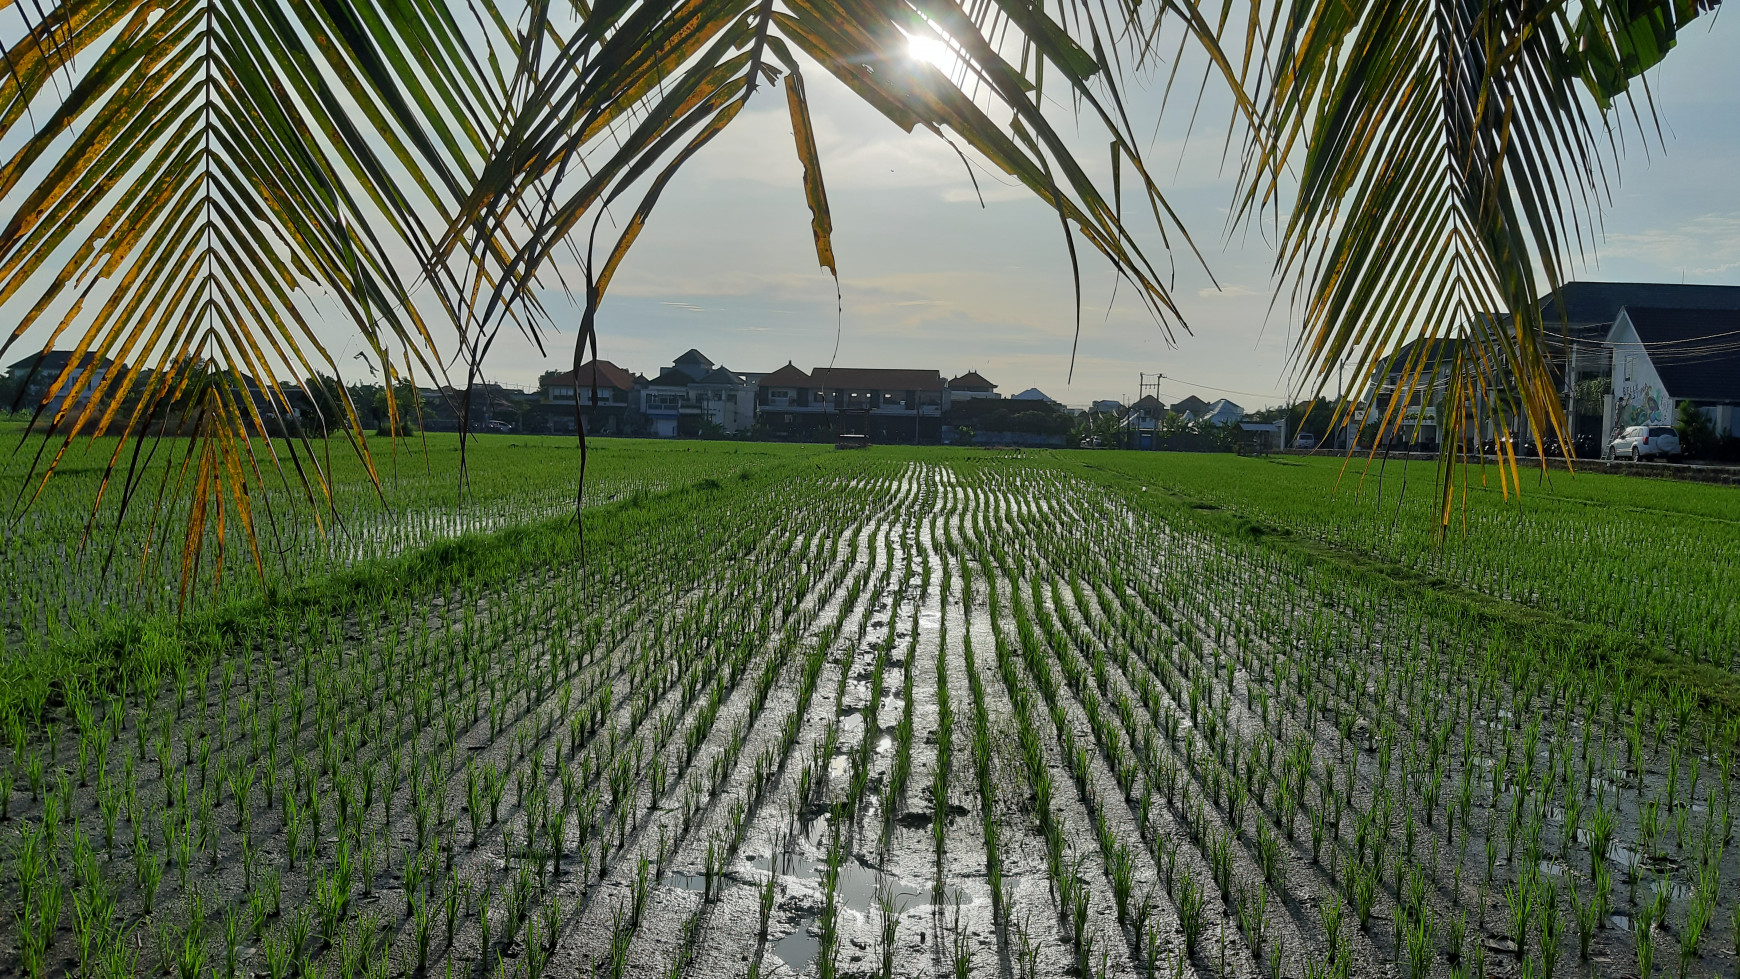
[1625,306,1740,405]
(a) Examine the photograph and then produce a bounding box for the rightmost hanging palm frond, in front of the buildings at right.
[1241,0,1712,523]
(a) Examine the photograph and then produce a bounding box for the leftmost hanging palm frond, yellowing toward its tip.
[0,0,508,567]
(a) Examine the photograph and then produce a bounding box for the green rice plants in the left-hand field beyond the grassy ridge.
[0,436,800,657]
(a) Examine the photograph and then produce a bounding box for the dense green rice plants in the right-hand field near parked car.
[1096,456,1740,666]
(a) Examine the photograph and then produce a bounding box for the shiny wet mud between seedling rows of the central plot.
[0,457,1740,979]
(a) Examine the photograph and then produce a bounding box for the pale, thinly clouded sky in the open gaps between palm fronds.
[473,16,1740,409]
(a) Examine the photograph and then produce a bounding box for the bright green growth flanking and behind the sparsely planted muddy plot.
[0,439,1740,723]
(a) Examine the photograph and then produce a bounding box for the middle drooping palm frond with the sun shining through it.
[442,0,1234,394]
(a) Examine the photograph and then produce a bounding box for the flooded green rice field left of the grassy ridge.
[0,423,813,657]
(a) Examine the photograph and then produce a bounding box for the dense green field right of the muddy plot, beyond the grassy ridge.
[1060,452,1740,669]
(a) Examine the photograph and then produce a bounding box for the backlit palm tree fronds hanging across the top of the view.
[0,0,1714,570]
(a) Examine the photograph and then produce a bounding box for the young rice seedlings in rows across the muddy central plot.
[0,457,1735,976]
